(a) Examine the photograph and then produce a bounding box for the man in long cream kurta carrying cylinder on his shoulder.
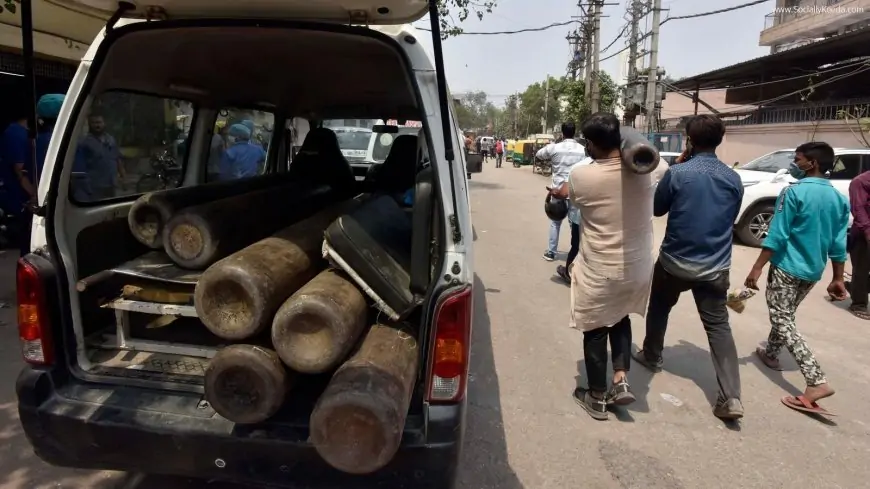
[551,113,653,420]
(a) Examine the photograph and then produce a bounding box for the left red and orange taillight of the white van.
[15,258,54,365]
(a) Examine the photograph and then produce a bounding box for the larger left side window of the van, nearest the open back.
[69,91,195,202]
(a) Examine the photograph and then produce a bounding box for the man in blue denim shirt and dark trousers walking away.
[634,114,743,420]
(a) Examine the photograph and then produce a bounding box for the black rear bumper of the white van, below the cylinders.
[16,367,465,489]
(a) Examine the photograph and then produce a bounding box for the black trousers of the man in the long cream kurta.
[583,316,631,392]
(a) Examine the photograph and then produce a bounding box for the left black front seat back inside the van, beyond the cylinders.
[288,127,356,189]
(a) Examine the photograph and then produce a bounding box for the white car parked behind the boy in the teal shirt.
[734,148,870,247]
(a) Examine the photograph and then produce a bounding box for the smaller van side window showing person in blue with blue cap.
[206,107,275,182]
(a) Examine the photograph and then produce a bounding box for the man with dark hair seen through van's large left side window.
[76,112,127,200]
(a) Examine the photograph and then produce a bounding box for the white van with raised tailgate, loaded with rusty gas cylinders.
[17,0,474,489]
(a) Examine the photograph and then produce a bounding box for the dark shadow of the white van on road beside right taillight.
[458,275,523,489]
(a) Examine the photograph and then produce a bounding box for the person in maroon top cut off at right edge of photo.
[847,168,870,320]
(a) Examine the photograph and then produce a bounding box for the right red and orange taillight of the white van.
[426,286,472,403]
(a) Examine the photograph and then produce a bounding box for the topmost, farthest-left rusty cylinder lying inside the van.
[127,173,302,249]
